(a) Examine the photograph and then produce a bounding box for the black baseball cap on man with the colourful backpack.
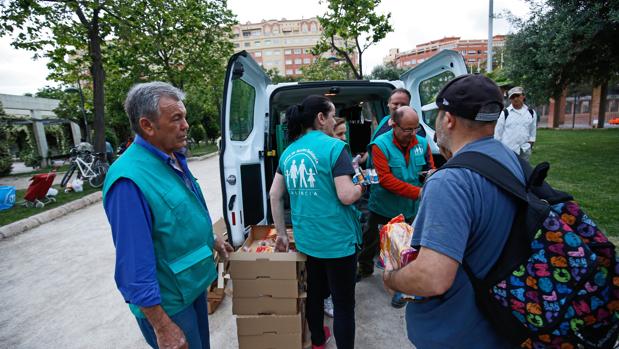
[436,74,503,121]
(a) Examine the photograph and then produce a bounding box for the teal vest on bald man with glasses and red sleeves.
[369,130,428,219]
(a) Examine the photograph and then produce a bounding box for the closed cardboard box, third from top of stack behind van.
[232,294,305,315]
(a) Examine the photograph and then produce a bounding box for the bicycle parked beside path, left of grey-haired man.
[60,147,109,188]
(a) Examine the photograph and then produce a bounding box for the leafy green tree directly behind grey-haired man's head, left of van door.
[106,0,236,139]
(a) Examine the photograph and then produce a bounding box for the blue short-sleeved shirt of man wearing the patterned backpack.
[406,137,524,349]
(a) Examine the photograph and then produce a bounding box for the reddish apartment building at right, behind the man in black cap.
[383,35,505,72]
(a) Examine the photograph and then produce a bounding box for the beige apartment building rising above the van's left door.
[232,17,354,76]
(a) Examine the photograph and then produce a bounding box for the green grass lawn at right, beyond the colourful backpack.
[531,128,619,237]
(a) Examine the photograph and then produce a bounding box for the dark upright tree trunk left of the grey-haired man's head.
[89,12,105,153]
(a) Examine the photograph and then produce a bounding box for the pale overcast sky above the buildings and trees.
[0,0,528,95]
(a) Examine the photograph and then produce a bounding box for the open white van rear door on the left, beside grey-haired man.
[219,51,271,246]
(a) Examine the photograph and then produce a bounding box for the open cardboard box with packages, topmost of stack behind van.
[230,225,306,280]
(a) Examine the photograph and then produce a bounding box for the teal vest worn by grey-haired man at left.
[103,144,217,318]
